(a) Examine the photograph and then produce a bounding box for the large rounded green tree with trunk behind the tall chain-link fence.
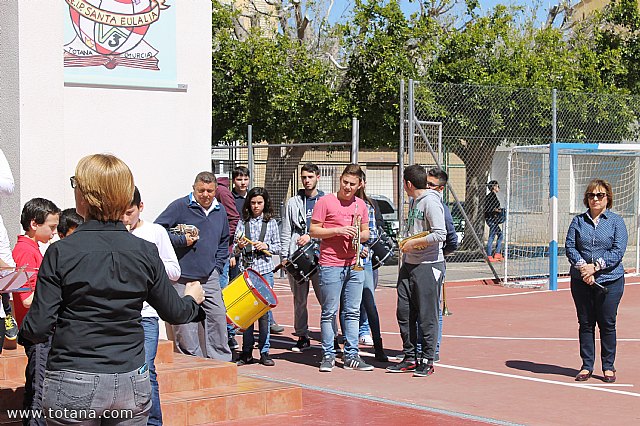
[416,5,629,248]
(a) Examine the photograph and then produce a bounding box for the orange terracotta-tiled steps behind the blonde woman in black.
[0,340,302,426]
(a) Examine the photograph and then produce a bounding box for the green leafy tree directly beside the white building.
[212,3,351,210]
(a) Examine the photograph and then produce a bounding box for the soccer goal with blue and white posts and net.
[504,143,640,290]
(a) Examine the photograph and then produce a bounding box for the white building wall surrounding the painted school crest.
[0,0,211,234]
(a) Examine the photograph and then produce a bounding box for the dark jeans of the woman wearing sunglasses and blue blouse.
[571,277,624,371]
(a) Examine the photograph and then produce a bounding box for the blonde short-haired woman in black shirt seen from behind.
[19,154,204,425]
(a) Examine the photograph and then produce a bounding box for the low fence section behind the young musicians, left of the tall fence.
[211,120,408,285]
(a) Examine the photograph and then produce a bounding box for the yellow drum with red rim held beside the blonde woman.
[222,269,278,331]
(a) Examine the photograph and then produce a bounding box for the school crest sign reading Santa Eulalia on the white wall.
[64,0,175,88]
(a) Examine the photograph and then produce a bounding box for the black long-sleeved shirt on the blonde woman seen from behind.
[20,220,205,374]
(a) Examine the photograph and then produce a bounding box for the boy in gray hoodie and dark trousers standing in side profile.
[387,164,447,377]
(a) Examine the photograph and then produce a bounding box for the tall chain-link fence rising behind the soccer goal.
[397,81,640,286]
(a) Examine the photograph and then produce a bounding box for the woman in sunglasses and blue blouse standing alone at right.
[565,179,627,383]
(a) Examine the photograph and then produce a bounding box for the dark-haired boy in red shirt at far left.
[13,198,60,425]
